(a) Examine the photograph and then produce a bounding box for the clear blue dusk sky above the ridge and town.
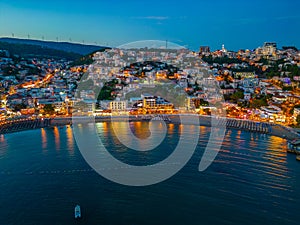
[0,0,300,50]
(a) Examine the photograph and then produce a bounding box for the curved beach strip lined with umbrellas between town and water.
[0,114,300,141]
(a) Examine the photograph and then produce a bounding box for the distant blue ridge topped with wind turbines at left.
[0,37,108,55]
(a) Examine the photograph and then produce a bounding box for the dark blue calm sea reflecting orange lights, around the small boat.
[0,122,300,225]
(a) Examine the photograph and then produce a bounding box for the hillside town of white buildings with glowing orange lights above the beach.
[0,42,300,126]
